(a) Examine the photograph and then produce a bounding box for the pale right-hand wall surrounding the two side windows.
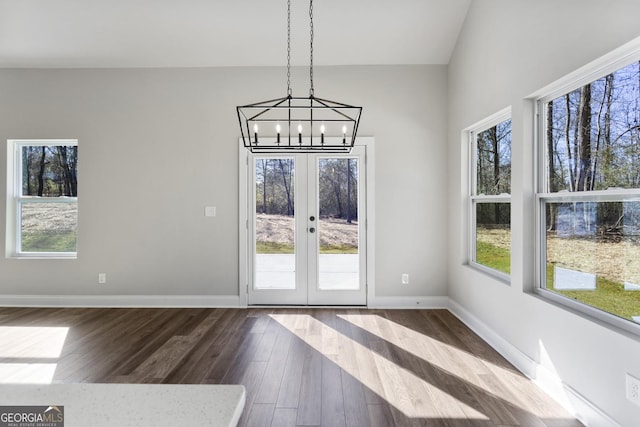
[448,0,640,426]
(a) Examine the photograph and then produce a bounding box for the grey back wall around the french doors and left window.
[0,66,447,305]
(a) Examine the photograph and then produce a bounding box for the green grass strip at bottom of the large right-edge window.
[547,263,640,320]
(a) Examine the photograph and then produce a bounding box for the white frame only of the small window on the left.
[5,139,78,259]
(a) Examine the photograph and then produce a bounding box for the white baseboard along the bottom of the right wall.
[449,299,621,427]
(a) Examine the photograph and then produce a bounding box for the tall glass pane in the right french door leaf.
[318,158,360,290]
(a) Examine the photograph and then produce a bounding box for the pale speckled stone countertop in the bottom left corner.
[0,383,245,427]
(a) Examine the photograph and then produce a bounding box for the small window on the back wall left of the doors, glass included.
[6,140,78,258]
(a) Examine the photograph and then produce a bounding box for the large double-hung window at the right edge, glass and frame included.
[537,44,640,332]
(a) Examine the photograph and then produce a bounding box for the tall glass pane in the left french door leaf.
[253,158,296,289]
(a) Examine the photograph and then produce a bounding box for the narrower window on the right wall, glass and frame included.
[468,109,511,278]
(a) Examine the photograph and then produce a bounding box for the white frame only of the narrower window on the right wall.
[465,106,513,284]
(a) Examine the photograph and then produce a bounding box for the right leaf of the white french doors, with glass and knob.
[307,146,367,305]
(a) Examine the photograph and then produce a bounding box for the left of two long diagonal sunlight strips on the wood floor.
[270,314,489,420]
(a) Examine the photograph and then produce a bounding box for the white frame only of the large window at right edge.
[530,39,640,336]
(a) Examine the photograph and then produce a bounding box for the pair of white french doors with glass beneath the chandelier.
[247,146,367,305]
